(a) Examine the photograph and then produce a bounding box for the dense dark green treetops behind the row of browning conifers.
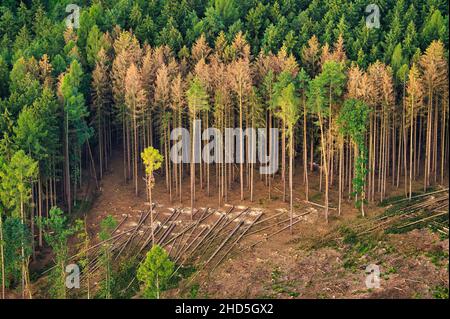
[0,0,448,85]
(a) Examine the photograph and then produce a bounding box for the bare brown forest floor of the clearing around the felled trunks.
[70,153,449,298]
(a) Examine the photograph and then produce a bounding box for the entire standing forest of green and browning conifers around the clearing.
[0,0,449,297]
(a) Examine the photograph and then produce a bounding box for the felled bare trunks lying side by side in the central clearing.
[58,206,311,296]
